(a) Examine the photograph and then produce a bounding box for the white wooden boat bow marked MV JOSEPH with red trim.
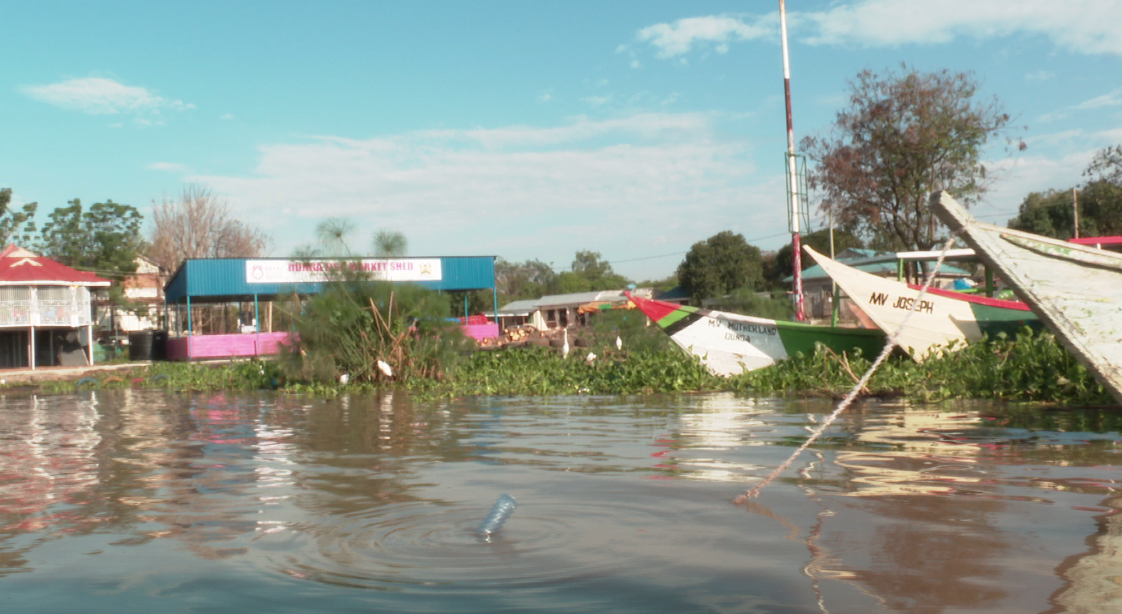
[803,246,1039,361]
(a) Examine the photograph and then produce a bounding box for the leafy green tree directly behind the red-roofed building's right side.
[38,199,147,304]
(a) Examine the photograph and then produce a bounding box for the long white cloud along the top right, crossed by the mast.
[637,0,1122,58]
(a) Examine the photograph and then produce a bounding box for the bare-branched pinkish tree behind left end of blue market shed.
[148,185,272,271]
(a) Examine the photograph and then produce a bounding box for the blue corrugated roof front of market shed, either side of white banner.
[164,256,495,303]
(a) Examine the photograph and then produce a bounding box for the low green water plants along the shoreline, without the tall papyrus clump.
[15,321,1115,406]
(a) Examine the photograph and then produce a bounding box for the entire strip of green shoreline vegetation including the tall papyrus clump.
[8,282,1116,406]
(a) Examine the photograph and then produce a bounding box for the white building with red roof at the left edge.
[0,245,110,369]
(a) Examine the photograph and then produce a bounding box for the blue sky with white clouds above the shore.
[0,0,1122,281]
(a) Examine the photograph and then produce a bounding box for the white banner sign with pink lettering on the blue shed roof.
[246,258,441,284]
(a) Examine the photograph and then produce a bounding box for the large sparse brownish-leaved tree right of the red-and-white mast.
[802,65,1024,249]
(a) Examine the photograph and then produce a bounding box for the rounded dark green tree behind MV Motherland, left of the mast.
[678,230,763,300]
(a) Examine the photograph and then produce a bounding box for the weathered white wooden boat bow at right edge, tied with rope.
[931,192,1122,402]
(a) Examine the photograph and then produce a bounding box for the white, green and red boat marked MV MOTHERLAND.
[627,294,885,376]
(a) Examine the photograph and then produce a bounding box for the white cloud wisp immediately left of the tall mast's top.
[635,15,775,58]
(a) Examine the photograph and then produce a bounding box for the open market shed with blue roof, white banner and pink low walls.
[164,256,498,360]
